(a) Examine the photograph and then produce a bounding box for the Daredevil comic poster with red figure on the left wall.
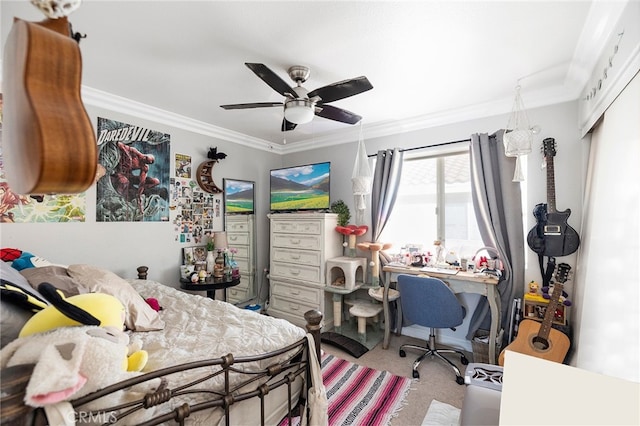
[96,117,171,222]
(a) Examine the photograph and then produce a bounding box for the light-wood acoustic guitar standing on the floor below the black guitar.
[498,263,571,365]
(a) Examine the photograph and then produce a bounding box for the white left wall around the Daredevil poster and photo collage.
[0,107,282,287]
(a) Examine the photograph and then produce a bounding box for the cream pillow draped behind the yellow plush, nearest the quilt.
[67,265,164,331]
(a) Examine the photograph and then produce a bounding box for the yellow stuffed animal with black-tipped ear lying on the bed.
[19,283,149,371]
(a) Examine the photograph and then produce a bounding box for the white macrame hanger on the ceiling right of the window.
[502,86,540,182]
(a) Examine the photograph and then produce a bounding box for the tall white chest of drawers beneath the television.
[267,213,342,329]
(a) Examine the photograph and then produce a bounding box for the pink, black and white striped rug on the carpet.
[280,353,412,426]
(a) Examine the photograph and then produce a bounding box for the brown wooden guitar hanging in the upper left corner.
[3,12,98,194]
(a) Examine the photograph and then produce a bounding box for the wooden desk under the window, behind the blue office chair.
[382,265,500,364]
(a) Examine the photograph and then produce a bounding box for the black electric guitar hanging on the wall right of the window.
[527,138,580,256]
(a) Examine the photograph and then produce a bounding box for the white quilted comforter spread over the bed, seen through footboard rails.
[129,280,306,426]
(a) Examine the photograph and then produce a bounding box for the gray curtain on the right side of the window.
[467,130,524,339]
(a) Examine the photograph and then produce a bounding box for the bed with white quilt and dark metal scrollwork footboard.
[0,262,322,425]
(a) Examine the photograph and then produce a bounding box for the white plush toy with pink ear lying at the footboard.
[0,326,163,424]
